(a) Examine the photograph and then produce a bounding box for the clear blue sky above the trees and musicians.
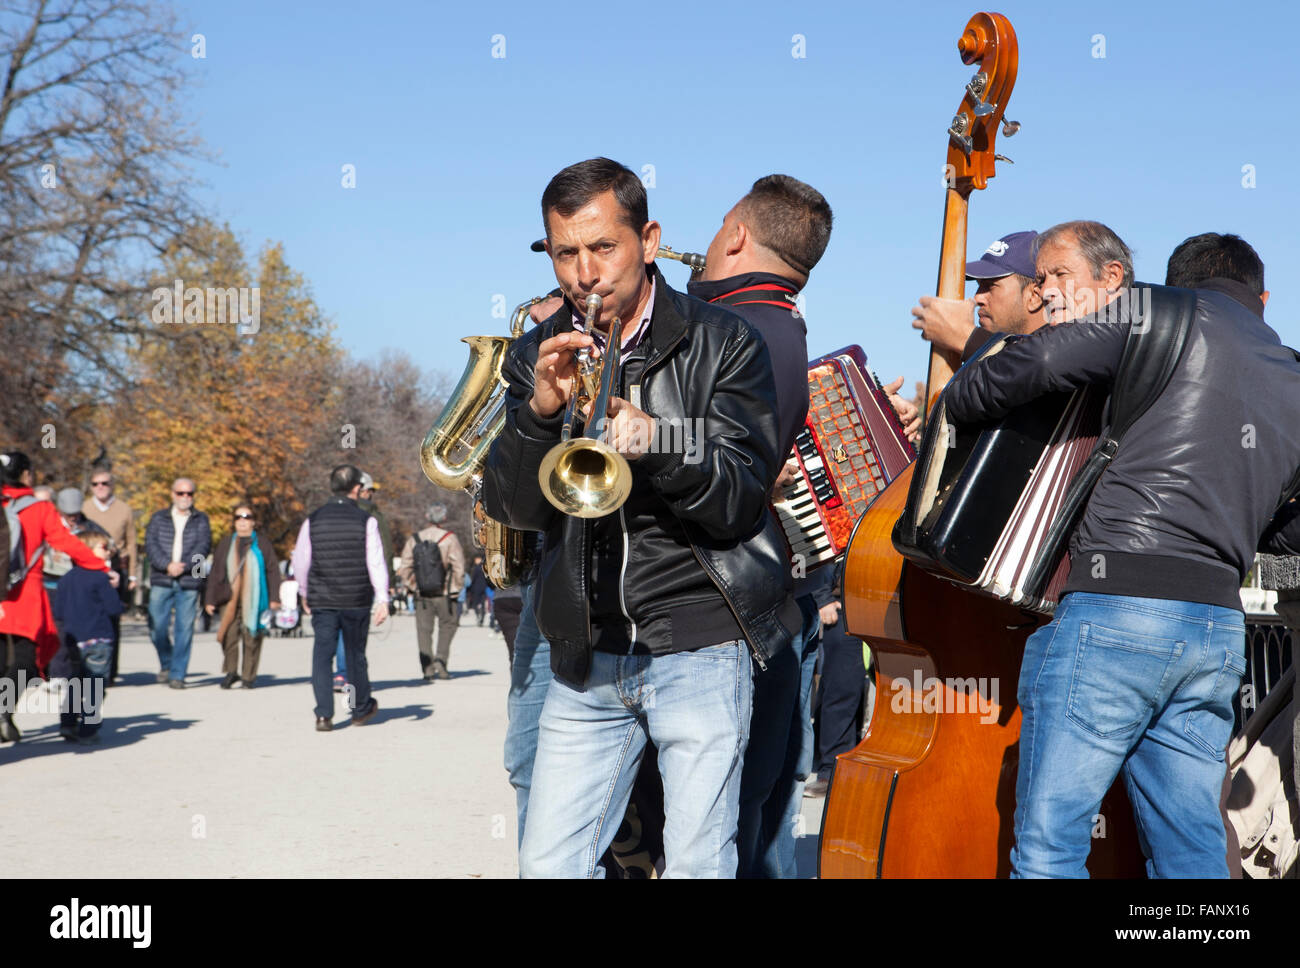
[179,0,1300,386]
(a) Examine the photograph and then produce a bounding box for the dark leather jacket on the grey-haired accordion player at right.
[945,283,1300,611]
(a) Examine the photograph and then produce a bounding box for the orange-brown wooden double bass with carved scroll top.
[819,13,1143,877]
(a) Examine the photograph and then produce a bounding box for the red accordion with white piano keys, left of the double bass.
[772,346,915,570]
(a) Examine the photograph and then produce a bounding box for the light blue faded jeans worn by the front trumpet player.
[519,639,751,877]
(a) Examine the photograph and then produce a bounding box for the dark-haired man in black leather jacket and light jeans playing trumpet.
[484,159,798,877]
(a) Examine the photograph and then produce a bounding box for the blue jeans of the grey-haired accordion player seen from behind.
[1011,592,1245,877]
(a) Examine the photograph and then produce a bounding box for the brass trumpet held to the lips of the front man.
[537,292,632,517]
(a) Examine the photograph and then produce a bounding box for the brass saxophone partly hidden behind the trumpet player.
[420,296,545,589]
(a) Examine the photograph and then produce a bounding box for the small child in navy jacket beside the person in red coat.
[49,529,122,743]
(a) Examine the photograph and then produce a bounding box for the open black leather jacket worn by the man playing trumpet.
[484,269,797,687]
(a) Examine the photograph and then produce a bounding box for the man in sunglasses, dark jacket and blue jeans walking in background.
[144,477,212,689]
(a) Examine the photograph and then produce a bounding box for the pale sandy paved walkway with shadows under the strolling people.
[0,615,822,877]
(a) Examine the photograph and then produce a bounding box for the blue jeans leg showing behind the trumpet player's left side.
[506,583,551,846]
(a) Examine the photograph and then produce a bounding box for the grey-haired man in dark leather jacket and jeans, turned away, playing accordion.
[945,222,1300,877]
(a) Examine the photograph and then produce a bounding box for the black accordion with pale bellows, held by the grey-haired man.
[893,340,1106,615]
